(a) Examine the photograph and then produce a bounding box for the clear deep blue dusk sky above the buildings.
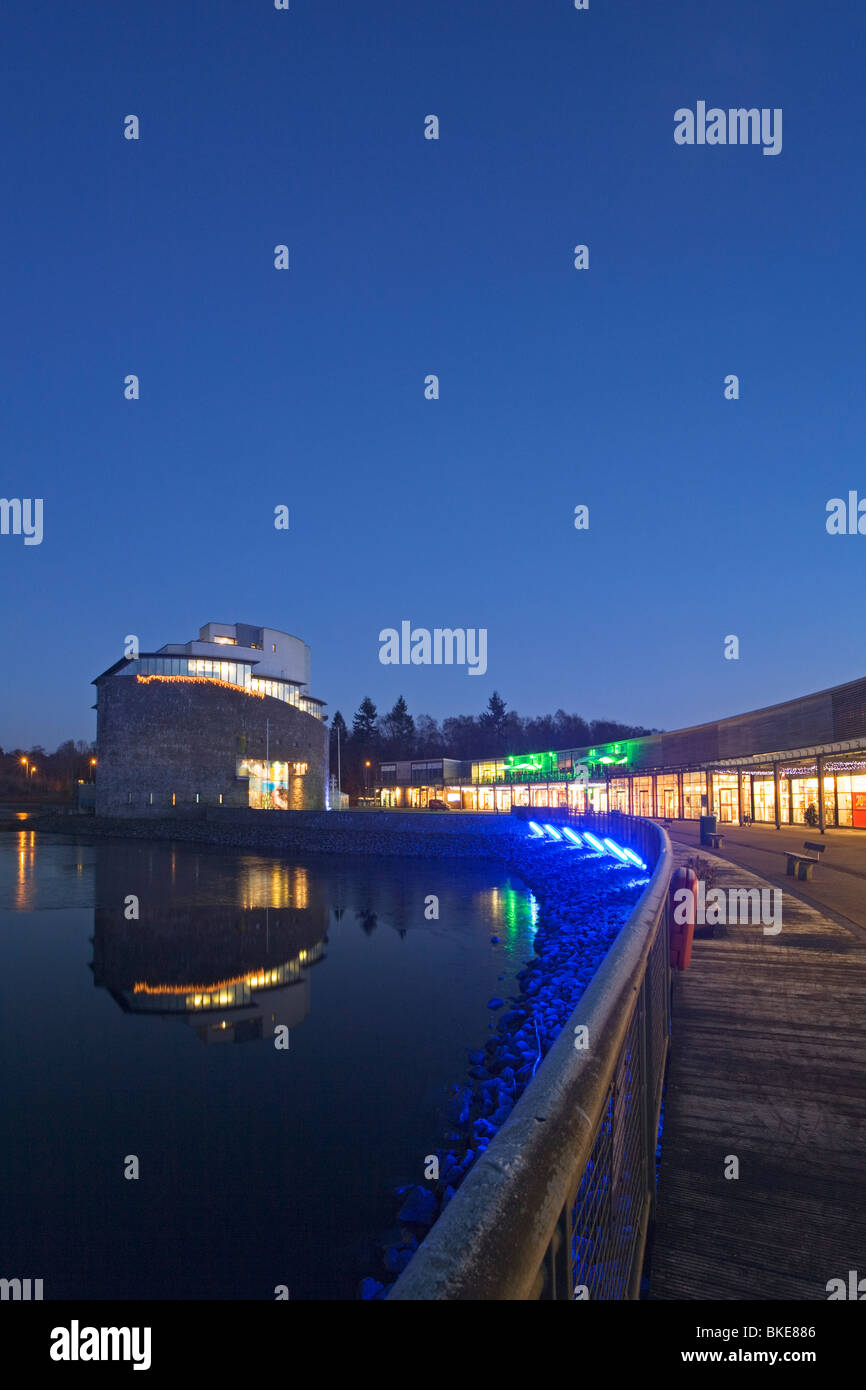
[0,0,866,748]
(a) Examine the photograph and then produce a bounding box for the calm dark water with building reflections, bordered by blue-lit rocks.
[0,830,534,1298]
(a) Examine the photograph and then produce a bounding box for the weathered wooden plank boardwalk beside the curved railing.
[649,844,866,1300]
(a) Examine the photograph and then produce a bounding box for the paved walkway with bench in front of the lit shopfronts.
[656,820,866,931]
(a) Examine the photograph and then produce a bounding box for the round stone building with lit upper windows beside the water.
[93,623,328,816]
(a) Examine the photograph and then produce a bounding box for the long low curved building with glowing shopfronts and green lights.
[377,678,866,828]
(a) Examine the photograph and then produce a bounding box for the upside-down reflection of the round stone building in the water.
[92,845,328,1043]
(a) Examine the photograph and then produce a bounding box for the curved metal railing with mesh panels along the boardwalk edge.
[388,812,671,1301]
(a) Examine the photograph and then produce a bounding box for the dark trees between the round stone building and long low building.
[331,691,657,798]
